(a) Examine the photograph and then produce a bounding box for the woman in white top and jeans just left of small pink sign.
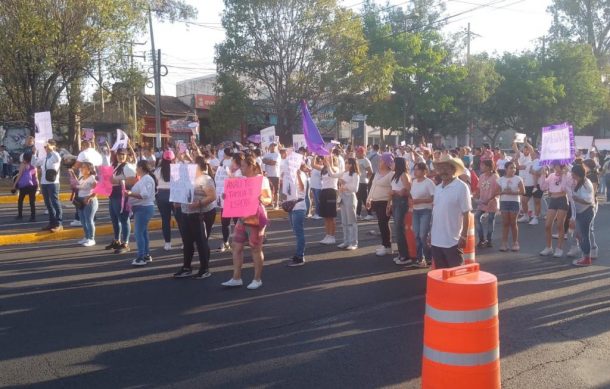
[70,162,98,247]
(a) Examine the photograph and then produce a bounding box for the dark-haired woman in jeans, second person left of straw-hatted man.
[388,157,414,265]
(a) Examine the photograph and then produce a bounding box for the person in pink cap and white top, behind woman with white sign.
[155,149,182,251]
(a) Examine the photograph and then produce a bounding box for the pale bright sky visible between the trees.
[144,0,551,96]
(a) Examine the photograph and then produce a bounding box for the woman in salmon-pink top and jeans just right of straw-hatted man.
[474,159,501,248]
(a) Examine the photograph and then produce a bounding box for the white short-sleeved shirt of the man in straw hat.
[430,178,472,248]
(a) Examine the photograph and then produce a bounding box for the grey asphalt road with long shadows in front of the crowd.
[0,211,610,389]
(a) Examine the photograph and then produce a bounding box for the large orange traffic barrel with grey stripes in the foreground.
[422,263,500,389]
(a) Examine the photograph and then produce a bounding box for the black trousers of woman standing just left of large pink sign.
[182,213,210,273]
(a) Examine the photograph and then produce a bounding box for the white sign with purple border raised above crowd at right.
[540,123,576,165]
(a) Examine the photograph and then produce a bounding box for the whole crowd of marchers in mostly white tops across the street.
[5,132,610,289]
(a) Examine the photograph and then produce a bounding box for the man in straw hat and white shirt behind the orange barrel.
[430,154,472,268]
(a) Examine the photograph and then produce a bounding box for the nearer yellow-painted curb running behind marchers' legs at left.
[0,210,287,246]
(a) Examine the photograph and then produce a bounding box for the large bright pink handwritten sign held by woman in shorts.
[222,176,263,217]
